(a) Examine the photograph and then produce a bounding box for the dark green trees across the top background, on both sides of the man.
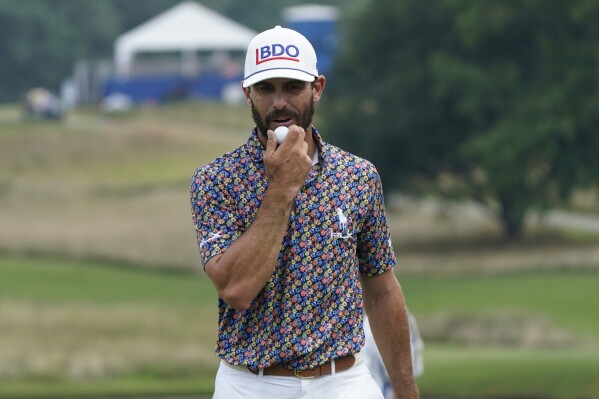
[0,0,599,237]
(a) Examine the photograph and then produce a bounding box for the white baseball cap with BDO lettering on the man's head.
[243,26,318,87]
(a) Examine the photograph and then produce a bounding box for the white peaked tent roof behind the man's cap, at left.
[114,1,257,75]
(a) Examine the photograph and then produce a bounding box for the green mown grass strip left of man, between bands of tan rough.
[0,256,216,306]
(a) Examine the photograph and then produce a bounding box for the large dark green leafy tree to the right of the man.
[324,0,599,238]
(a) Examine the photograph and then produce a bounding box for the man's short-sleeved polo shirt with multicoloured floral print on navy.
[191,128,396,370]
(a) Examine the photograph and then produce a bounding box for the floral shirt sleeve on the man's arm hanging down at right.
[357,166,397,276]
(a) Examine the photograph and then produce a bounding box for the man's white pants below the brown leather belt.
[212,362,383,399]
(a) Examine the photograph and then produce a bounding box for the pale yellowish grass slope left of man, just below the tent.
[0,102,252,187]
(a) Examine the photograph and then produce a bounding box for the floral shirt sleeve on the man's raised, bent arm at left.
[190,167,241,267]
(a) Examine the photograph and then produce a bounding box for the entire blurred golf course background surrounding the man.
[0,0,599,399]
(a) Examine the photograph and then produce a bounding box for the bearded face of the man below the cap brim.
[247,78,314,138]
